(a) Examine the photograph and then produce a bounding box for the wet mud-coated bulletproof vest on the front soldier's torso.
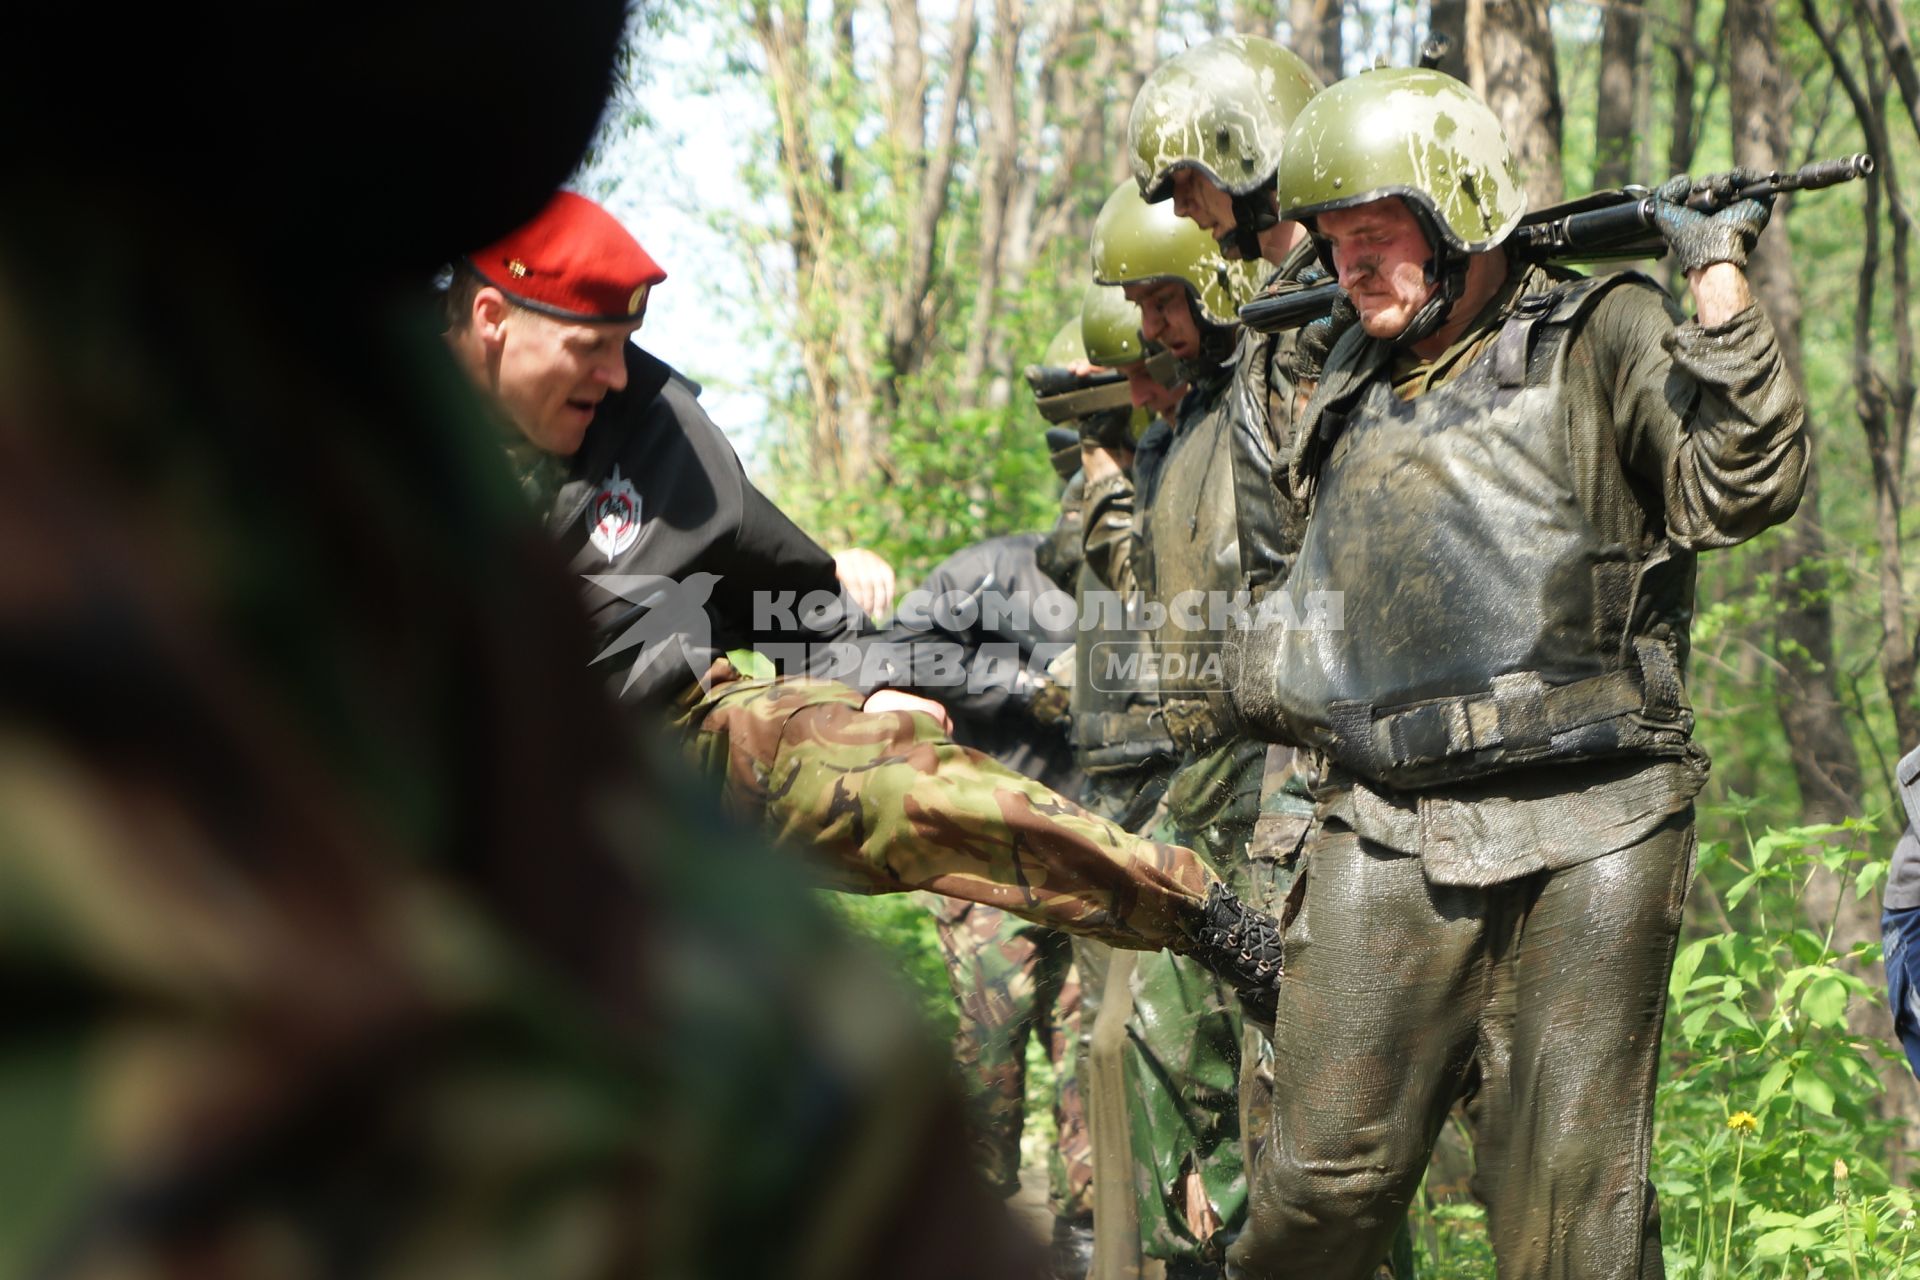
[1261,274,1693,787]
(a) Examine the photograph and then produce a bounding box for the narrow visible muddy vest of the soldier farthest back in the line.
[1069,564,1173,773]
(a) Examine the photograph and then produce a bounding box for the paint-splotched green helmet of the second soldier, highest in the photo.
[1127,36,1321,203]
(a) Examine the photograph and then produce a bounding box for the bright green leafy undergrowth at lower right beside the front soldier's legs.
[1415,825,1920,1280]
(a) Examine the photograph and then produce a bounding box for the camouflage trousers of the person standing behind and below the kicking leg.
[933,898,1092,1219]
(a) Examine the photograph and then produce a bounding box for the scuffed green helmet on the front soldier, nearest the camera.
[1279,67,1526,253]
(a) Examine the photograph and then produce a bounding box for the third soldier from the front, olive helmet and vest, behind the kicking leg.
[1085,182,1265,1274]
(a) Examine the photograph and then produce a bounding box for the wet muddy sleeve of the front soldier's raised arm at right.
[1594,288,1807,551]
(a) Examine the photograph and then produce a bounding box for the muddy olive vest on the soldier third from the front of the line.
[1137,367,1244,750]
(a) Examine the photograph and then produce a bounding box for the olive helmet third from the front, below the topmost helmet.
[1092,182,1263,328]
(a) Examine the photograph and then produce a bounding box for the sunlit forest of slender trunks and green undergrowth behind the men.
[606,0,1920,1278]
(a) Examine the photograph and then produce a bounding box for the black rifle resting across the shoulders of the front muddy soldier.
[1240,154,1874,334]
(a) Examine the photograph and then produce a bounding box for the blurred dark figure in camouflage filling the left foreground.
[0,0,1035,1280]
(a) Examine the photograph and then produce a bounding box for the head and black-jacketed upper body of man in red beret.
[447,192,898,722]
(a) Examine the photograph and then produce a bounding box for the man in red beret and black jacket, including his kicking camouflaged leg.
[445,192,1271,998]
